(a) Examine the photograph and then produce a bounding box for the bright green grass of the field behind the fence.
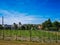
[0,30,60,40]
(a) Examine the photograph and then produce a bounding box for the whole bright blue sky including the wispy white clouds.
[0,0,60,24]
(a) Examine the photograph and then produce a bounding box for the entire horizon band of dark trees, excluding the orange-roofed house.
[0,19,60,31]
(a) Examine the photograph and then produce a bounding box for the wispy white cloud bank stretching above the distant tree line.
[0,10,46,24]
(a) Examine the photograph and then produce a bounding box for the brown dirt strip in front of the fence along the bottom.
[0,40,60,45]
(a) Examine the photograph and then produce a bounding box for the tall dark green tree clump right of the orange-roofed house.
[42,19,60,31]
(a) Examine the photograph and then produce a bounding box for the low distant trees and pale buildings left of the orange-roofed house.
[0,22,38,30]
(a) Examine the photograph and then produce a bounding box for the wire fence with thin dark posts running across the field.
[0,30,60,42]
